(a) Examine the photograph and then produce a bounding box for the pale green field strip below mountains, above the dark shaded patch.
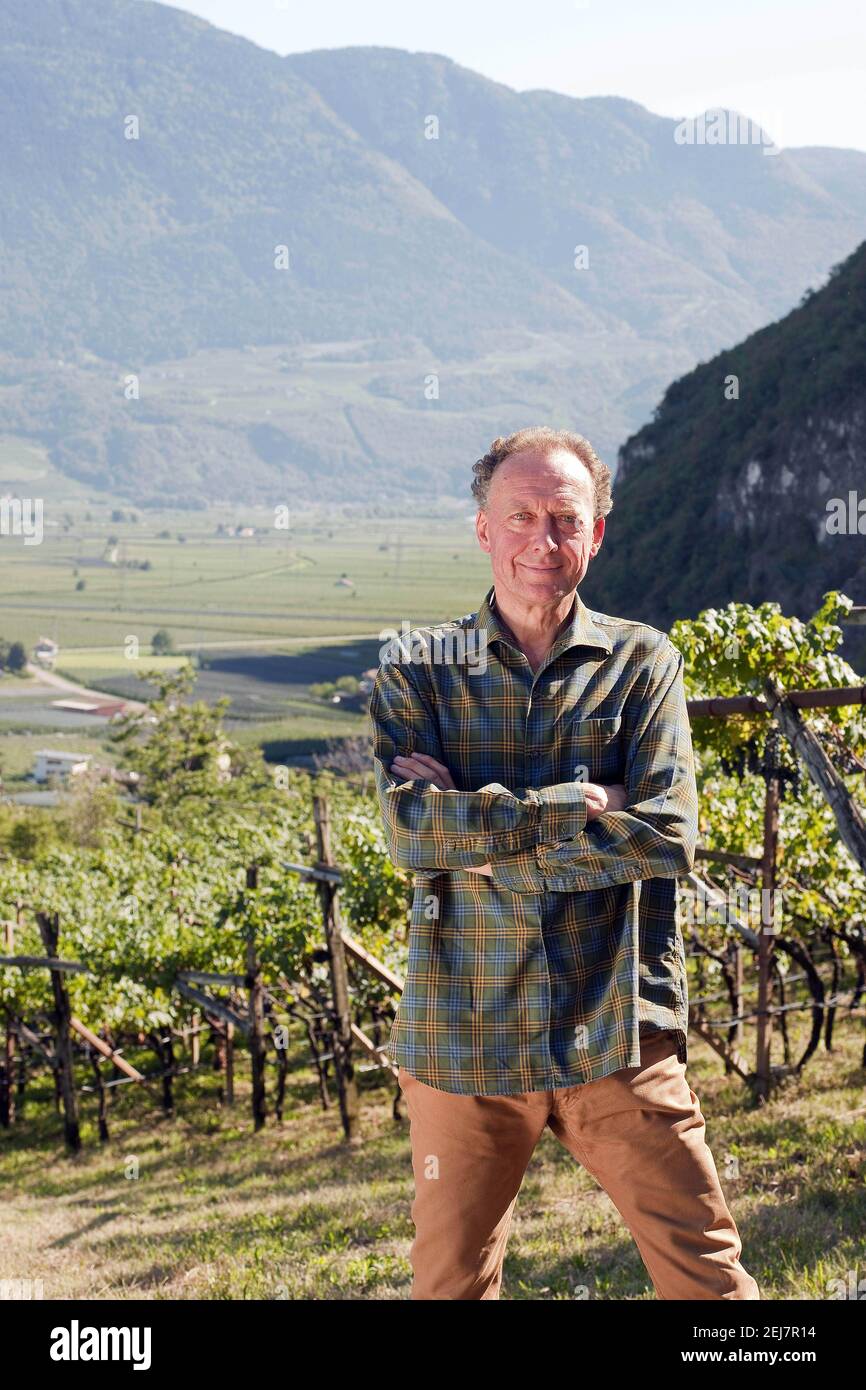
[0,507,489,647]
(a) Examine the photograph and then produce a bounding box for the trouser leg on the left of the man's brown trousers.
[399,1068,553,1300]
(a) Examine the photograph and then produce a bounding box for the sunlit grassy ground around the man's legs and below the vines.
[0,1020,866,1301]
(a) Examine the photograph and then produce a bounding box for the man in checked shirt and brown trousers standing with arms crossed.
[371,428,760,1300]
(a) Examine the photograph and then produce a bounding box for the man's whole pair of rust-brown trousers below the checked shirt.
[399,1031,760,1300]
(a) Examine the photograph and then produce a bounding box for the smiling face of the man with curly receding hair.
[475,449,605,605]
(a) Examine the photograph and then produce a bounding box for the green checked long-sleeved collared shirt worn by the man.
[370,587,698,1095]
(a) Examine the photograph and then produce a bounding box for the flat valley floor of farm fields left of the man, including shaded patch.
[0,478,489,778]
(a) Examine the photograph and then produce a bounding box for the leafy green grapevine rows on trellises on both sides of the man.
[0,594,866,1152]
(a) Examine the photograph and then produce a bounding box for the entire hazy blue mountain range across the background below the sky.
[0,0,866,506]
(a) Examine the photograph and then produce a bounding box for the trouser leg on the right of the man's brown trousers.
[549,1033,760,1300]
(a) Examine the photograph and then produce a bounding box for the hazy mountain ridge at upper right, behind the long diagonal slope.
[286,49,866,356]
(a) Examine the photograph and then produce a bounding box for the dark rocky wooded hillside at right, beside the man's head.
[585,243,866,651]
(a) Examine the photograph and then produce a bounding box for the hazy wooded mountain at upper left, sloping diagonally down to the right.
[0,0,599,361]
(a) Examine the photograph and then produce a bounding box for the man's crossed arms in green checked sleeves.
[370,641,698,892]
